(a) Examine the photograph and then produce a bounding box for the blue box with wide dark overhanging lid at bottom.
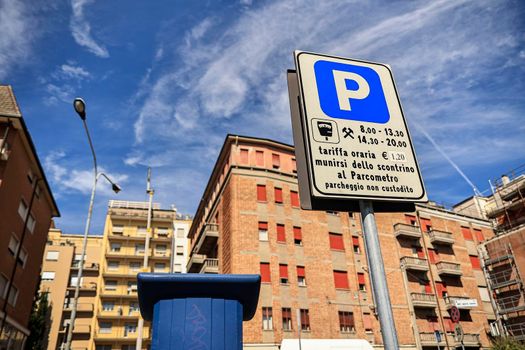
[137,273,261,350]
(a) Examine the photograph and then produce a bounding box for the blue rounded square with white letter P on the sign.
[314,60,390,124]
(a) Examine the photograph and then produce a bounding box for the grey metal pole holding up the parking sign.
[359,200,399,350]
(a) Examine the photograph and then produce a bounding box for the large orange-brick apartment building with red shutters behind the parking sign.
[188,135,495,350]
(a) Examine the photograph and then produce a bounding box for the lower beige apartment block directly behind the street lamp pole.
[40,228,103,350]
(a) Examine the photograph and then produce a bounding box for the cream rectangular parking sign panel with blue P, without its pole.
[295,51,427,202]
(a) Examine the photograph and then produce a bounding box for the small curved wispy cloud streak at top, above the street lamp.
[69,0,109,58]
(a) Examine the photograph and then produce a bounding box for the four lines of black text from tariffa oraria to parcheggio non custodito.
[314,146,416,193]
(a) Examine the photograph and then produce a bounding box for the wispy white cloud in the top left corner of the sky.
[0,0,34,79]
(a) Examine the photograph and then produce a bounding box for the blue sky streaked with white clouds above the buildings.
[0,0,525,233]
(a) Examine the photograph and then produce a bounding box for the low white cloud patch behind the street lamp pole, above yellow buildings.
[44,151,128,196]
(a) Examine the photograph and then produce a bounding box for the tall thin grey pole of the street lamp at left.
[65,119,100,350]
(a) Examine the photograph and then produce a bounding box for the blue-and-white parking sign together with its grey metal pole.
[288,51,427,350]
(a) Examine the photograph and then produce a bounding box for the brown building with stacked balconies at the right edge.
[455,165,525,342]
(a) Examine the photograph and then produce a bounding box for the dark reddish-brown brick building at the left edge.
[0,85,59,349]
